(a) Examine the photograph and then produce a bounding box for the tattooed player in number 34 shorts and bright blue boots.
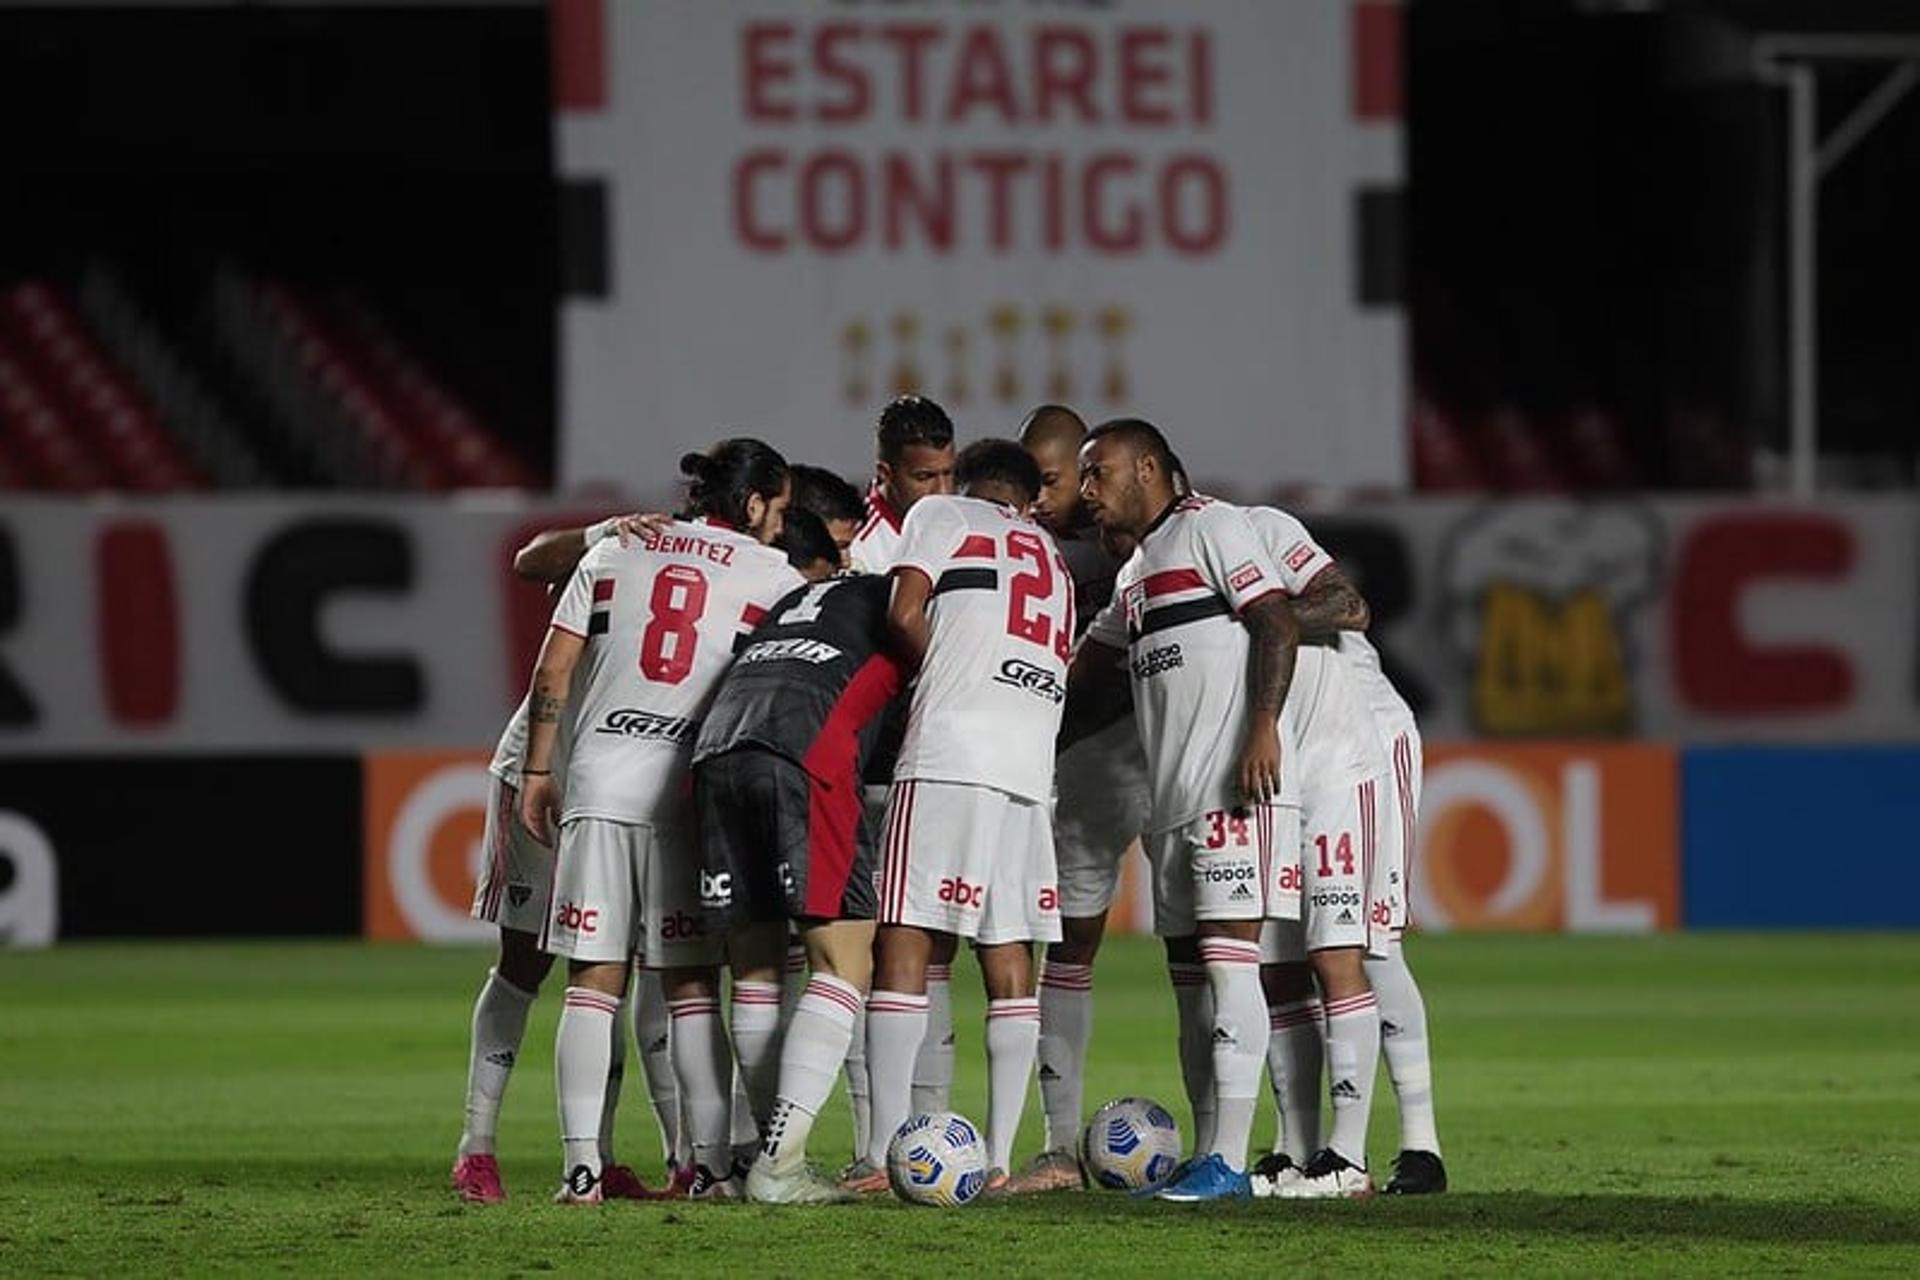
[1062,418,1300,1201]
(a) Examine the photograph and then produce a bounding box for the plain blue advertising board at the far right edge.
[1682,747,1920,929]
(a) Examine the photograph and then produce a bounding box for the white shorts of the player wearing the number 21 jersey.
[879,779,1060,946]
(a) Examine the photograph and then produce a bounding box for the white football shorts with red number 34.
[1140,804,1300,938]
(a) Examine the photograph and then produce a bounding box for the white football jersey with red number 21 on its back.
[893,495,1073,802]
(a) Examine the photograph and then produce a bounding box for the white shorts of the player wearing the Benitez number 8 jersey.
[540,818,724,969]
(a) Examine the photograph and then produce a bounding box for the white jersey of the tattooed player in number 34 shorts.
[1087,495,1300,831]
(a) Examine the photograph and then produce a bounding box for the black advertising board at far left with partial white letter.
[0,756,361,946]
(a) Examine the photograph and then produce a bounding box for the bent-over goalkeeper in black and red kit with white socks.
[693,525,900,1203]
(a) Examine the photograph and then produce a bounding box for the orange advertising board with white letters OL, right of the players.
[1409,743,1680,933]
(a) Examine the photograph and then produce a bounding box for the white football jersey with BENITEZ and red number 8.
[553,520,803,821]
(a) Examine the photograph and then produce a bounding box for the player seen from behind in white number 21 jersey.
[860,439,1073,1190]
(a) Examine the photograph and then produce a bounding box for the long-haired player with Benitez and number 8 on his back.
[520,439,801,1203]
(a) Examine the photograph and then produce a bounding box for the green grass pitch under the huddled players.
[0,935,1920,1276]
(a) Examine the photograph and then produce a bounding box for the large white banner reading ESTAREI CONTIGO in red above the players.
[557,0,1409,487]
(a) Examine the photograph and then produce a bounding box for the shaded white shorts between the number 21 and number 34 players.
[1054,716,1150,919]
